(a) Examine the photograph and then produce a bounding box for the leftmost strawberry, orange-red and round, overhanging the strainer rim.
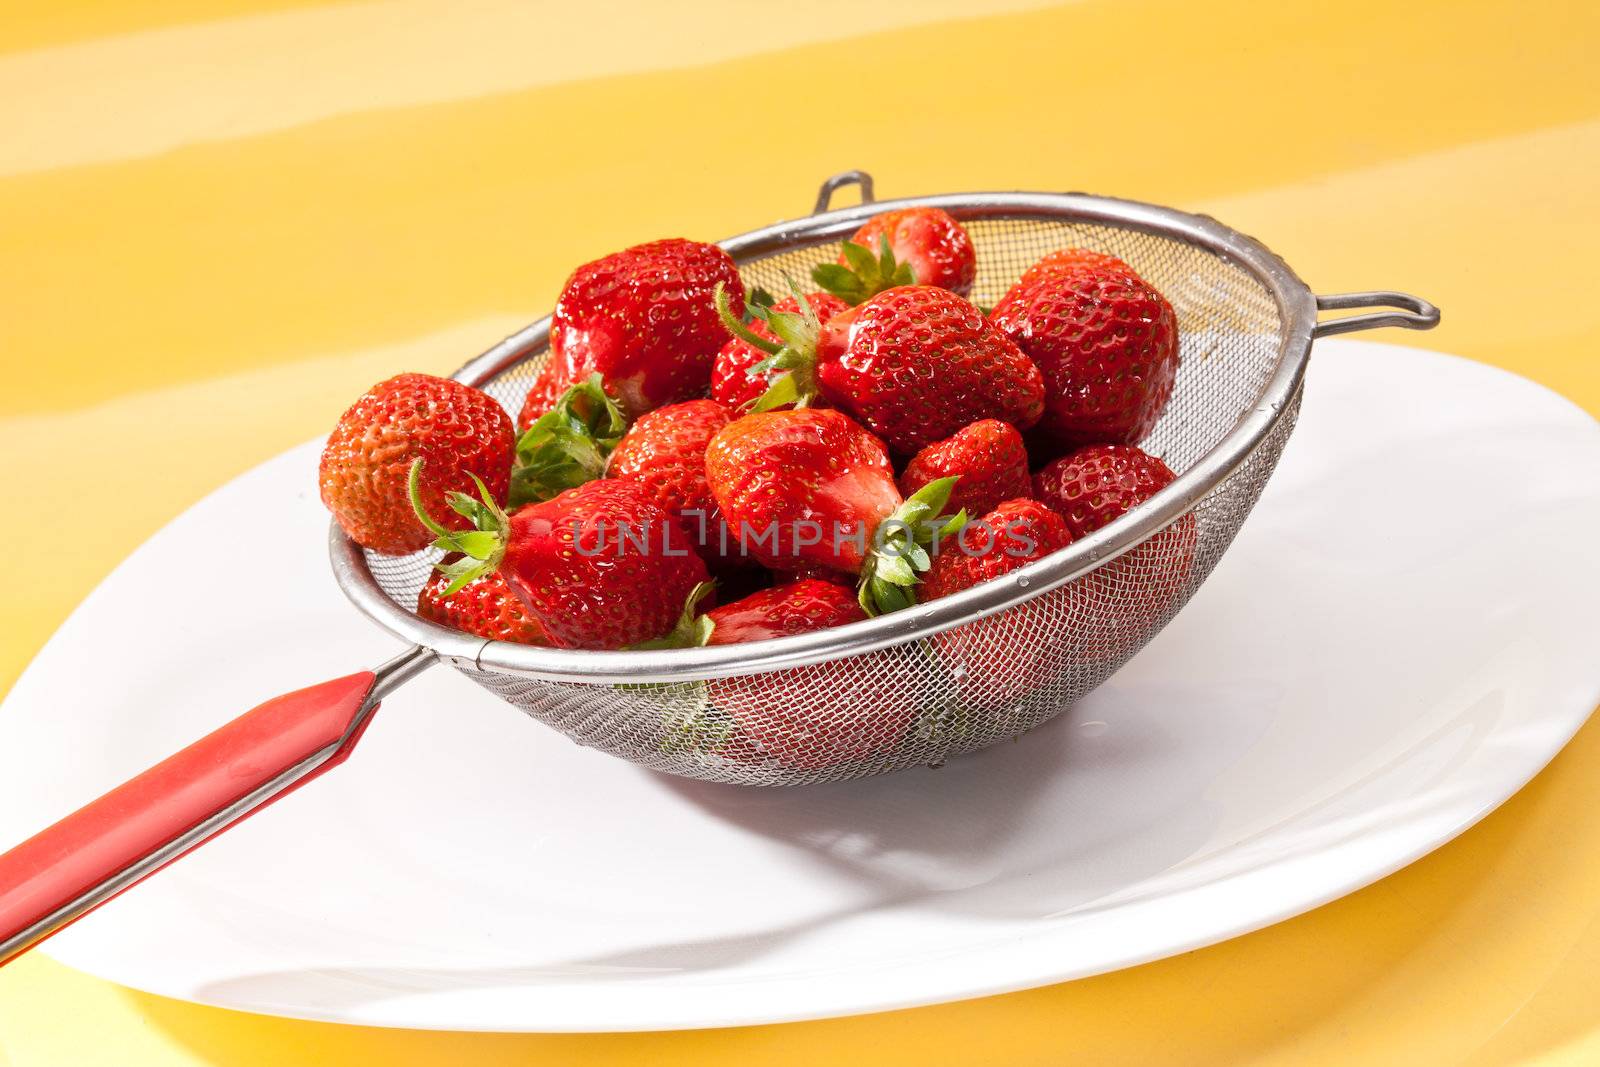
[318,374,512,555]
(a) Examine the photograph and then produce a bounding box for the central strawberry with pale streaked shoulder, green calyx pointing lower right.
[706,410,965,614]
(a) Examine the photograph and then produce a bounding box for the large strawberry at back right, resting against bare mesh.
[990,269,1178,450]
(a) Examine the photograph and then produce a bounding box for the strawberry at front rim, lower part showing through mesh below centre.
[706,579,915,769]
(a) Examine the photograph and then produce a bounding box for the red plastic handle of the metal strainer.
[0,670,374,963]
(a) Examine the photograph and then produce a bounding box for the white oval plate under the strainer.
[0,342,1600,1030]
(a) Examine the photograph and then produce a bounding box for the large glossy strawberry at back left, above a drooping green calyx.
[550,238,744,416]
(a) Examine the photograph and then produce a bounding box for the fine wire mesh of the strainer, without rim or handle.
[356,218,1299,785]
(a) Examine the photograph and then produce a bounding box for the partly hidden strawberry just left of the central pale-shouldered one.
[606,400,733,560]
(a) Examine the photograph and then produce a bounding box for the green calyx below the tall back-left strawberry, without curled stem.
[507,374,627,509]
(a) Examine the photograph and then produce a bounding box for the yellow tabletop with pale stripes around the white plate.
[0,0,1600,1067]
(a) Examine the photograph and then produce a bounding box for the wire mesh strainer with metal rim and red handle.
[0,171,1438,960]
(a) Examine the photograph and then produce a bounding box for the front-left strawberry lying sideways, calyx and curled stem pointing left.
[411,461,710,649]
